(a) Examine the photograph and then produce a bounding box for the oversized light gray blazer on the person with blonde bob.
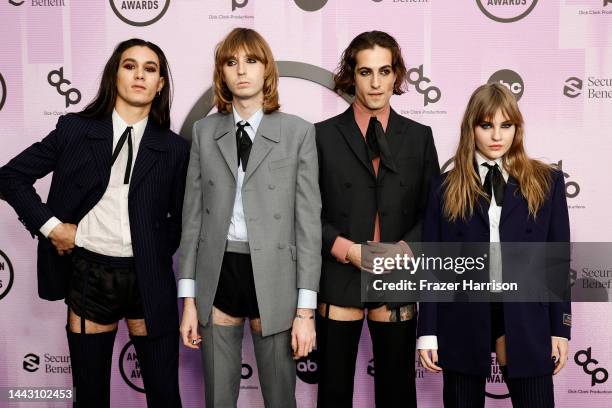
[180,112,321,336]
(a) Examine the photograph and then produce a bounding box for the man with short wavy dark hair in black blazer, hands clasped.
[316,31,439,408]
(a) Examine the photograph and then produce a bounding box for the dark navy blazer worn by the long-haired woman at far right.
[417,171,571,377]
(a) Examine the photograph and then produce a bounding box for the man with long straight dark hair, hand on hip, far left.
[0,39,189,407]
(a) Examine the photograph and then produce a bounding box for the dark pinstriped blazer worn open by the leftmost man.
[0,114,189,336]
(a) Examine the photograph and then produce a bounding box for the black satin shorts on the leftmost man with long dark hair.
[66,247,144,324]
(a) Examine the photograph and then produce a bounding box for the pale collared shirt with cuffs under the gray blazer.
[178,109,317,309]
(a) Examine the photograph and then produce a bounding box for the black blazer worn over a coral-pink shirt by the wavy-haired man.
[315,106,440,307]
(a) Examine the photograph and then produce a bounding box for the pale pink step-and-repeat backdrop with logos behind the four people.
[0,0,612,408]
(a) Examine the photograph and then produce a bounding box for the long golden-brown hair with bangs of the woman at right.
[444,84,552,221]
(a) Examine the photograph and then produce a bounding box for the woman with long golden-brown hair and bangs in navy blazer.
[417,84,571,408]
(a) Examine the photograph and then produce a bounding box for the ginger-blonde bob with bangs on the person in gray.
[213,28,280,113]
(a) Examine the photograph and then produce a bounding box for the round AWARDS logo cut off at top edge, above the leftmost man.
[109,0,170,27]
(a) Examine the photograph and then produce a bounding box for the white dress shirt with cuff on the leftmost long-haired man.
[40,110,148,257]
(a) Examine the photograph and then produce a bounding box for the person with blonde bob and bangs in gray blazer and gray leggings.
[179,28,321,408]
